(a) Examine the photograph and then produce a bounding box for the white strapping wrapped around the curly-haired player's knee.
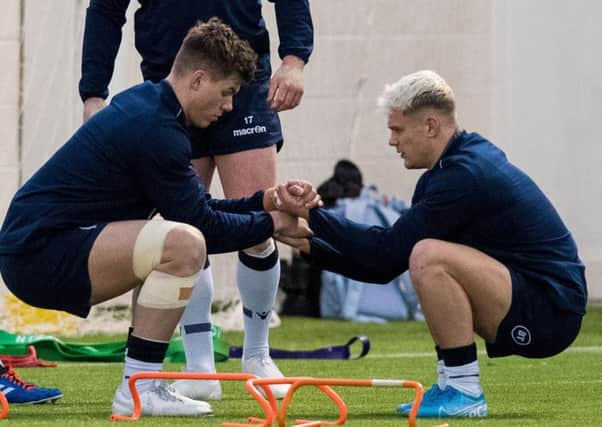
[133,218,200,309]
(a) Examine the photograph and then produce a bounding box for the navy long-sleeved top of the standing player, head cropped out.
[79,0,313,101]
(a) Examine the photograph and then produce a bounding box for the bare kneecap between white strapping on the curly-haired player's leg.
[165,224,207,277]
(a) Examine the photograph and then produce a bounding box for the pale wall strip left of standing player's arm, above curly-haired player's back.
[21,0,85,179]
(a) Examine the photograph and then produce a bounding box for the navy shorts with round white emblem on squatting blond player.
[487,269,583,358]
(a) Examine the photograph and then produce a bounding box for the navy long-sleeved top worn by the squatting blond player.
[308,132,587,314]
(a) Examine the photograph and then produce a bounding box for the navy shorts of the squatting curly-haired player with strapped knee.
[0,224,105,317]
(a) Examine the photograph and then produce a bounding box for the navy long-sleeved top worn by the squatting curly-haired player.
[0,80,274,254]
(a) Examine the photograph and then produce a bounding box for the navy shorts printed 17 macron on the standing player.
[190,80,283,159]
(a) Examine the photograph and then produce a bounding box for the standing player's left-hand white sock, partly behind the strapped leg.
[180,267,215,373]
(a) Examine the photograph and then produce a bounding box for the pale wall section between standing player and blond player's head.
[274,0,493,199]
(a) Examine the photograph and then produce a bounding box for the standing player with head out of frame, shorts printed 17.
[79,0,313,399]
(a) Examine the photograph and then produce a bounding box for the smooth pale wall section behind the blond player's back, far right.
[493,0,602,299]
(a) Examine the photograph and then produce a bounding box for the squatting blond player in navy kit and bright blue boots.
[279,70,587,417]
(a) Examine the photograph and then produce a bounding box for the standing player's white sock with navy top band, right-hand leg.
[238,244,280,359]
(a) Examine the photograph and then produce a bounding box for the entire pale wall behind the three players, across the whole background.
[0,0,602,308]
